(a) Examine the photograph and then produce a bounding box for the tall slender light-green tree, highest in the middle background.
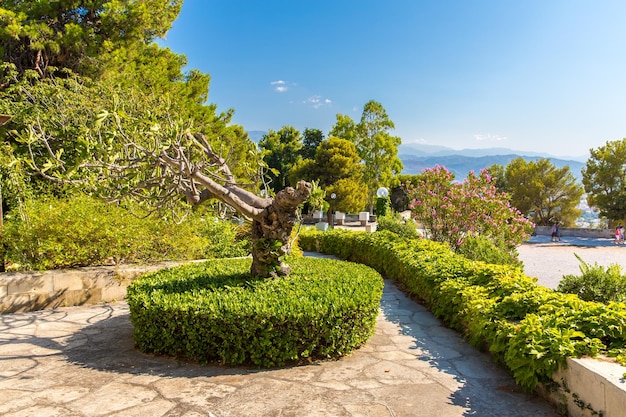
[331,100,402,208]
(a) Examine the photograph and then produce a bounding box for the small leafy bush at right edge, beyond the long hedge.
[557,254,626,304]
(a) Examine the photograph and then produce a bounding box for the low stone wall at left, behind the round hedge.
[0,262,194,314]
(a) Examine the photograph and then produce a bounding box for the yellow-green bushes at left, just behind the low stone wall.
[2,196,247,270]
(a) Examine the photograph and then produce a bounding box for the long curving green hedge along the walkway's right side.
[299,229,626,390]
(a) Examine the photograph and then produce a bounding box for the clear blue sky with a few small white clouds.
[162,0,626,156]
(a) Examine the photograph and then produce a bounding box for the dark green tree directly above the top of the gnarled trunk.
[259,126,302,192]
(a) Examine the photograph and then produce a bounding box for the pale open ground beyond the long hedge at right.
[518,243,626,288]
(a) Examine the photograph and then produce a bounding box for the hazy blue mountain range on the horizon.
[248,130,588,182]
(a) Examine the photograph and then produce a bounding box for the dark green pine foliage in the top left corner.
[0,0,183,76]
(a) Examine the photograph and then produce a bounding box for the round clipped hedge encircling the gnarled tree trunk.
[127,258,383,367]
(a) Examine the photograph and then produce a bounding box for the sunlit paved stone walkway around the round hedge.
[0,281,557,417]
